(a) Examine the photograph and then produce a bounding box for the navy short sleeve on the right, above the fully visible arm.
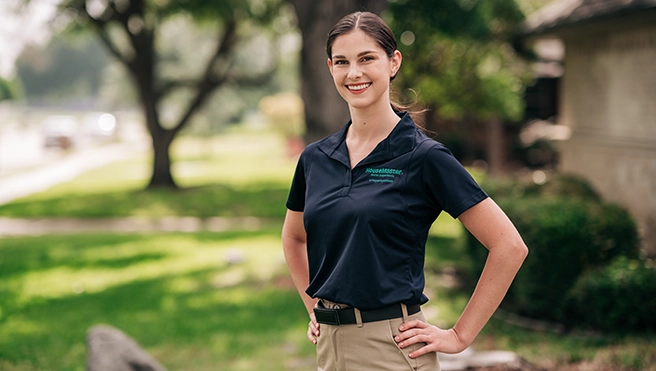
[423,143,488,218]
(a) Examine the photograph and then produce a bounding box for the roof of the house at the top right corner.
[521,0,656,35]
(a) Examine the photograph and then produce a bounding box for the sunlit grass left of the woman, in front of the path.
[0,228,313,370]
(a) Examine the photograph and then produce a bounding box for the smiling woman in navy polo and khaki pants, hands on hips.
[282,12,528,370]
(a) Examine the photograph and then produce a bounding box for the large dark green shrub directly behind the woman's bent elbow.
[467,177,639,322]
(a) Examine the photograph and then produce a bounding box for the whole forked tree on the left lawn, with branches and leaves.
[55,0,279,188]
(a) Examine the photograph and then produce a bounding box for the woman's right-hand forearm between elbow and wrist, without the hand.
[453,242,528,349]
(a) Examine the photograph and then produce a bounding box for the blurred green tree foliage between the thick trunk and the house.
[388,0,528,171]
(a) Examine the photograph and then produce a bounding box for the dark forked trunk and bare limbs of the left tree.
[69,0,239,188]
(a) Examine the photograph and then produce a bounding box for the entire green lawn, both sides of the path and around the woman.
[0,131,656,371]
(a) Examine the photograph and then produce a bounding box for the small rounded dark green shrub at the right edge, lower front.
[566,258,656,333]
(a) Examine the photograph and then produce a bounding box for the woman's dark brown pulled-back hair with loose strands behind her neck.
[326,12,425,119]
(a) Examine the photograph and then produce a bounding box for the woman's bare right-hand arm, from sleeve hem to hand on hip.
[396,198,528,358]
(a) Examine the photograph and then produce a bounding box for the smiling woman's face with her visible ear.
[328,30,401,109]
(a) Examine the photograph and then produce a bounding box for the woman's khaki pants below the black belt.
[317,304,440,371]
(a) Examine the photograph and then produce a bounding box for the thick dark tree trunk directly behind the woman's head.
[292,0,387,143]
